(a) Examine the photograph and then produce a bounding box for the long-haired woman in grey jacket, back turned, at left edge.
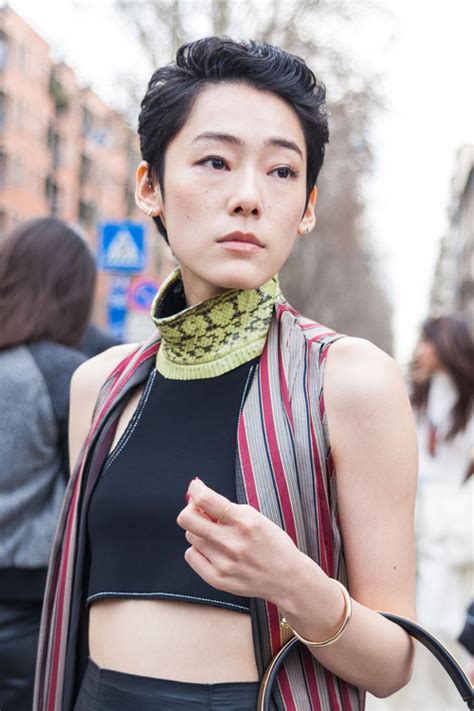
[0,218,95,711]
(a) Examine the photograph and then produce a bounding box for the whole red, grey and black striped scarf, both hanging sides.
[33,301,364,711]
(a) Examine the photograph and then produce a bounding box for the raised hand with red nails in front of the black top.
[177,479,312,604]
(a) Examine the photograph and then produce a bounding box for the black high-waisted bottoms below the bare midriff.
[74,659,259,711]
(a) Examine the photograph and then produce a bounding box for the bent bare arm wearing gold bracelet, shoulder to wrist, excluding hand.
[280,338,417,696]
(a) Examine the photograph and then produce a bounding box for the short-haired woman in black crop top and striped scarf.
[36,37,416,711]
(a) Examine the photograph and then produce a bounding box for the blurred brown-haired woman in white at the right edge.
[380,316,474,710]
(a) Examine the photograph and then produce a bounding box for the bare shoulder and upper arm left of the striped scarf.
[69,343,137,472]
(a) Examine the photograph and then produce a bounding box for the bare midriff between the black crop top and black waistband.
[89,599,258,684]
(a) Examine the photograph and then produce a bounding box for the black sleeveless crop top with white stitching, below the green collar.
[87,358,259,612]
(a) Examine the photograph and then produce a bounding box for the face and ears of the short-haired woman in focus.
[137,83,316,305]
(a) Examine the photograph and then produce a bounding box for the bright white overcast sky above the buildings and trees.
[10,0,474,365]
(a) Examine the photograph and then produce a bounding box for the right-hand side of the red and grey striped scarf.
[237,303,364,711]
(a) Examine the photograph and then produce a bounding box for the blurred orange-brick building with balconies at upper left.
[0,3,172,334]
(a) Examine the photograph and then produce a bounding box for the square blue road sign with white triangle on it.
[97,220,146,274]
